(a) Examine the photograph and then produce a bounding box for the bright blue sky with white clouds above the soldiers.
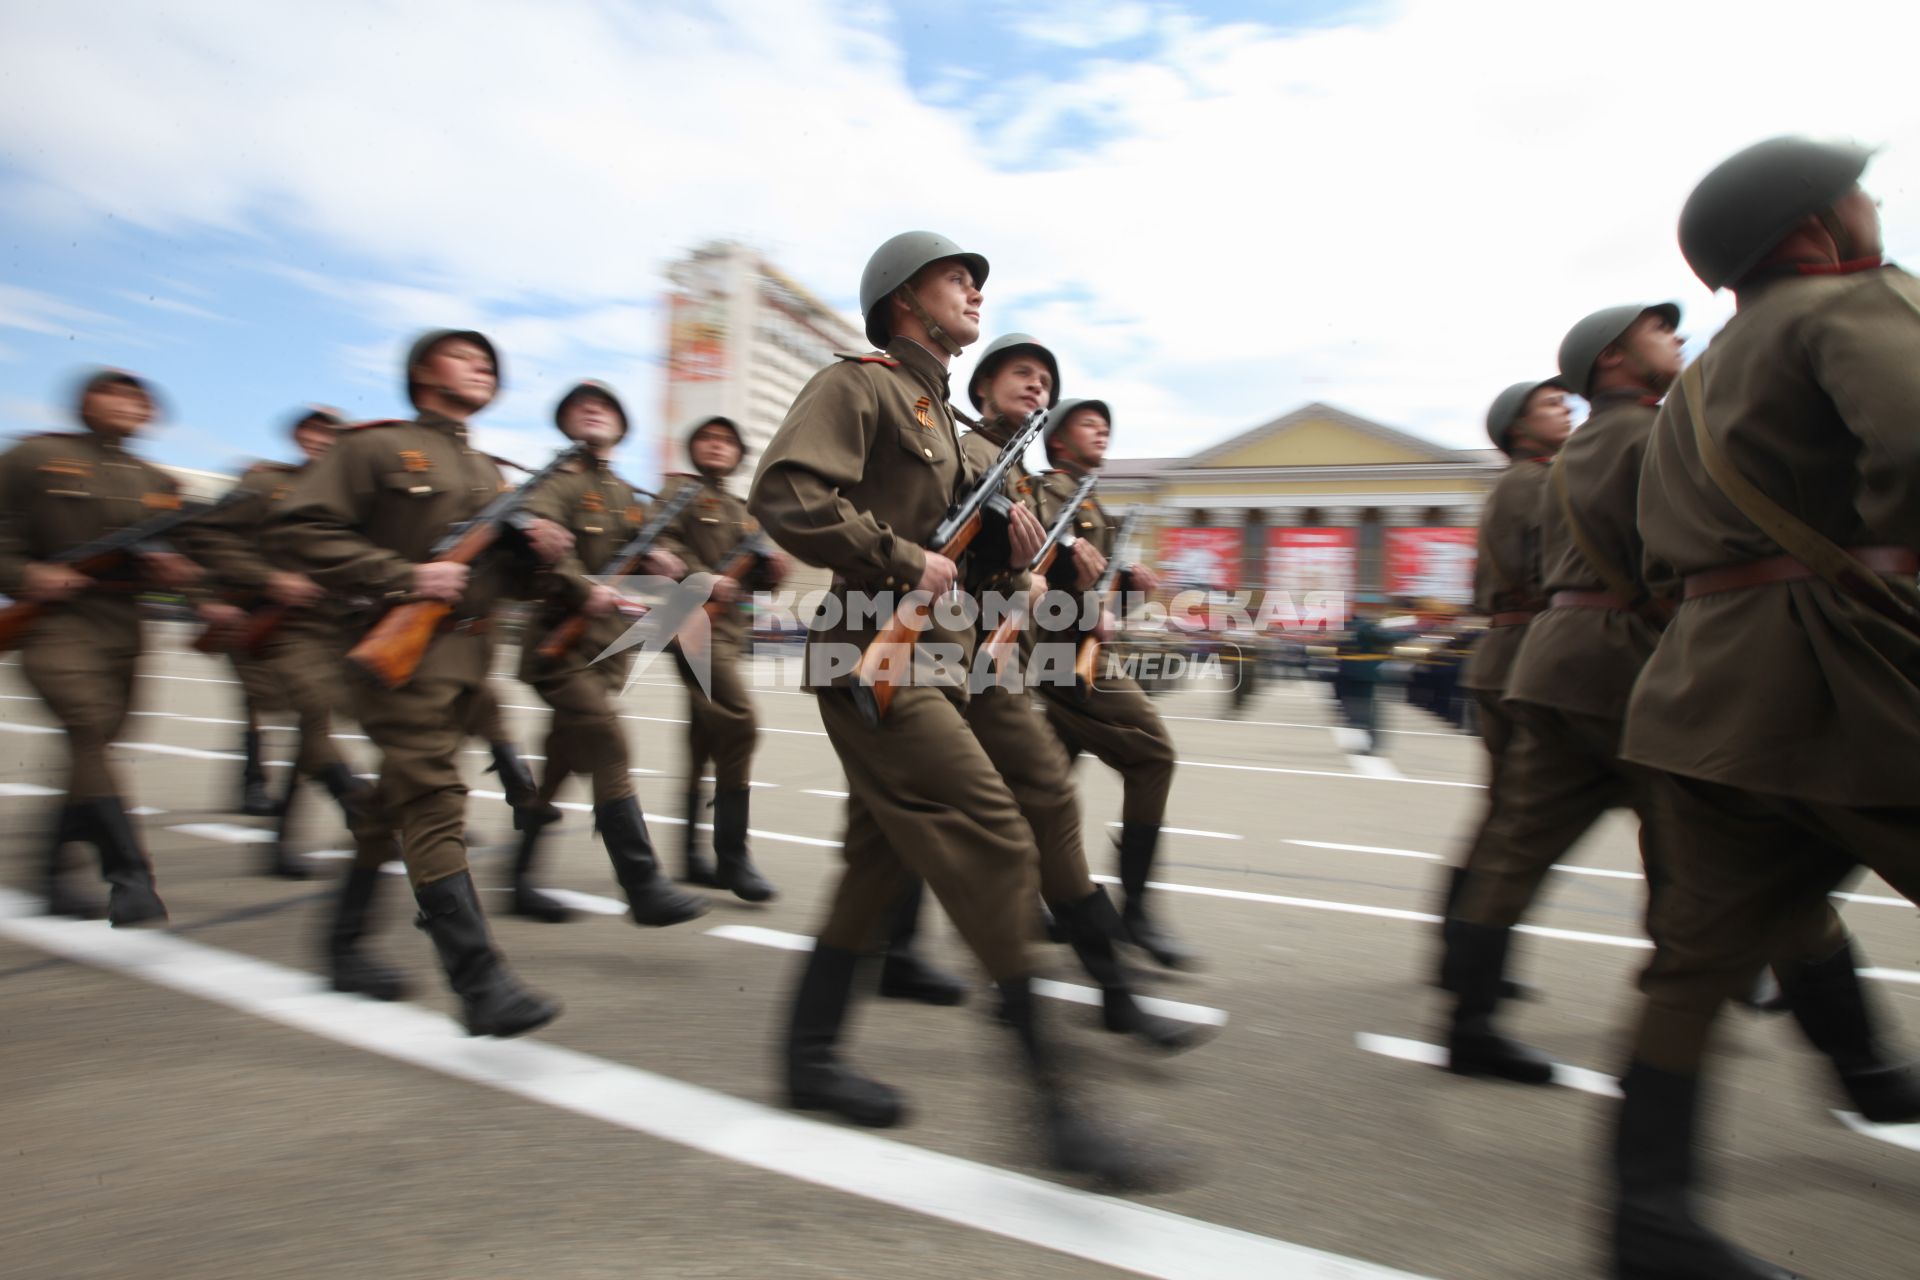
[0,0,1920,482]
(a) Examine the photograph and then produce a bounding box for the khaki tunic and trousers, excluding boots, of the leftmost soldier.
[0,432,184,800]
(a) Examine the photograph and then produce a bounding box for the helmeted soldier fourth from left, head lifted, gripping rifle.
[513,382,707,925]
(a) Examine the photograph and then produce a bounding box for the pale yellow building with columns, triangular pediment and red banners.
[1100,403,1507,604]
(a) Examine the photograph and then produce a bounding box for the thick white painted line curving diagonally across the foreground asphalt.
[0,892,1421,1280]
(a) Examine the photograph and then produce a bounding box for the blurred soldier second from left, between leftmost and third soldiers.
[196,405,371,881]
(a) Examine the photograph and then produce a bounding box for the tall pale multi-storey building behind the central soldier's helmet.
[660,240,868,478]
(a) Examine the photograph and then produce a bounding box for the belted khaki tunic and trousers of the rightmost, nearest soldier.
[1622,267,1920,1071]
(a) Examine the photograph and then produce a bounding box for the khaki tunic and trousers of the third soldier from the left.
[267,413,588,887]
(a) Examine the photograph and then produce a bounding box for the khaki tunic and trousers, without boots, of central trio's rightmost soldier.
[1039,470,1173,825]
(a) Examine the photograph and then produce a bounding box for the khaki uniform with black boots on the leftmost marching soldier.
[0,416,180,925]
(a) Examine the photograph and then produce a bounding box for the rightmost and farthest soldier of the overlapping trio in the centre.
[1039,399,1198,969]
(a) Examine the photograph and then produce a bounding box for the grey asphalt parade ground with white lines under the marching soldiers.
[0,626,1920,1280]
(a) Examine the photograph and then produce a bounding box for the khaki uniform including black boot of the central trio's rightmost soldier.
[1037,466,1192,965]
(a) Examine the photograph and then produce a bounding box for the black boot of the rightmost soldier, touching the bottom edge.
[1613,1063,1803,1280]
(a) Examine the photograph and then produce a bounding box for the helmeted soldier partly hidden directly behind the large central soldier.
[881,334,1208,1052]
